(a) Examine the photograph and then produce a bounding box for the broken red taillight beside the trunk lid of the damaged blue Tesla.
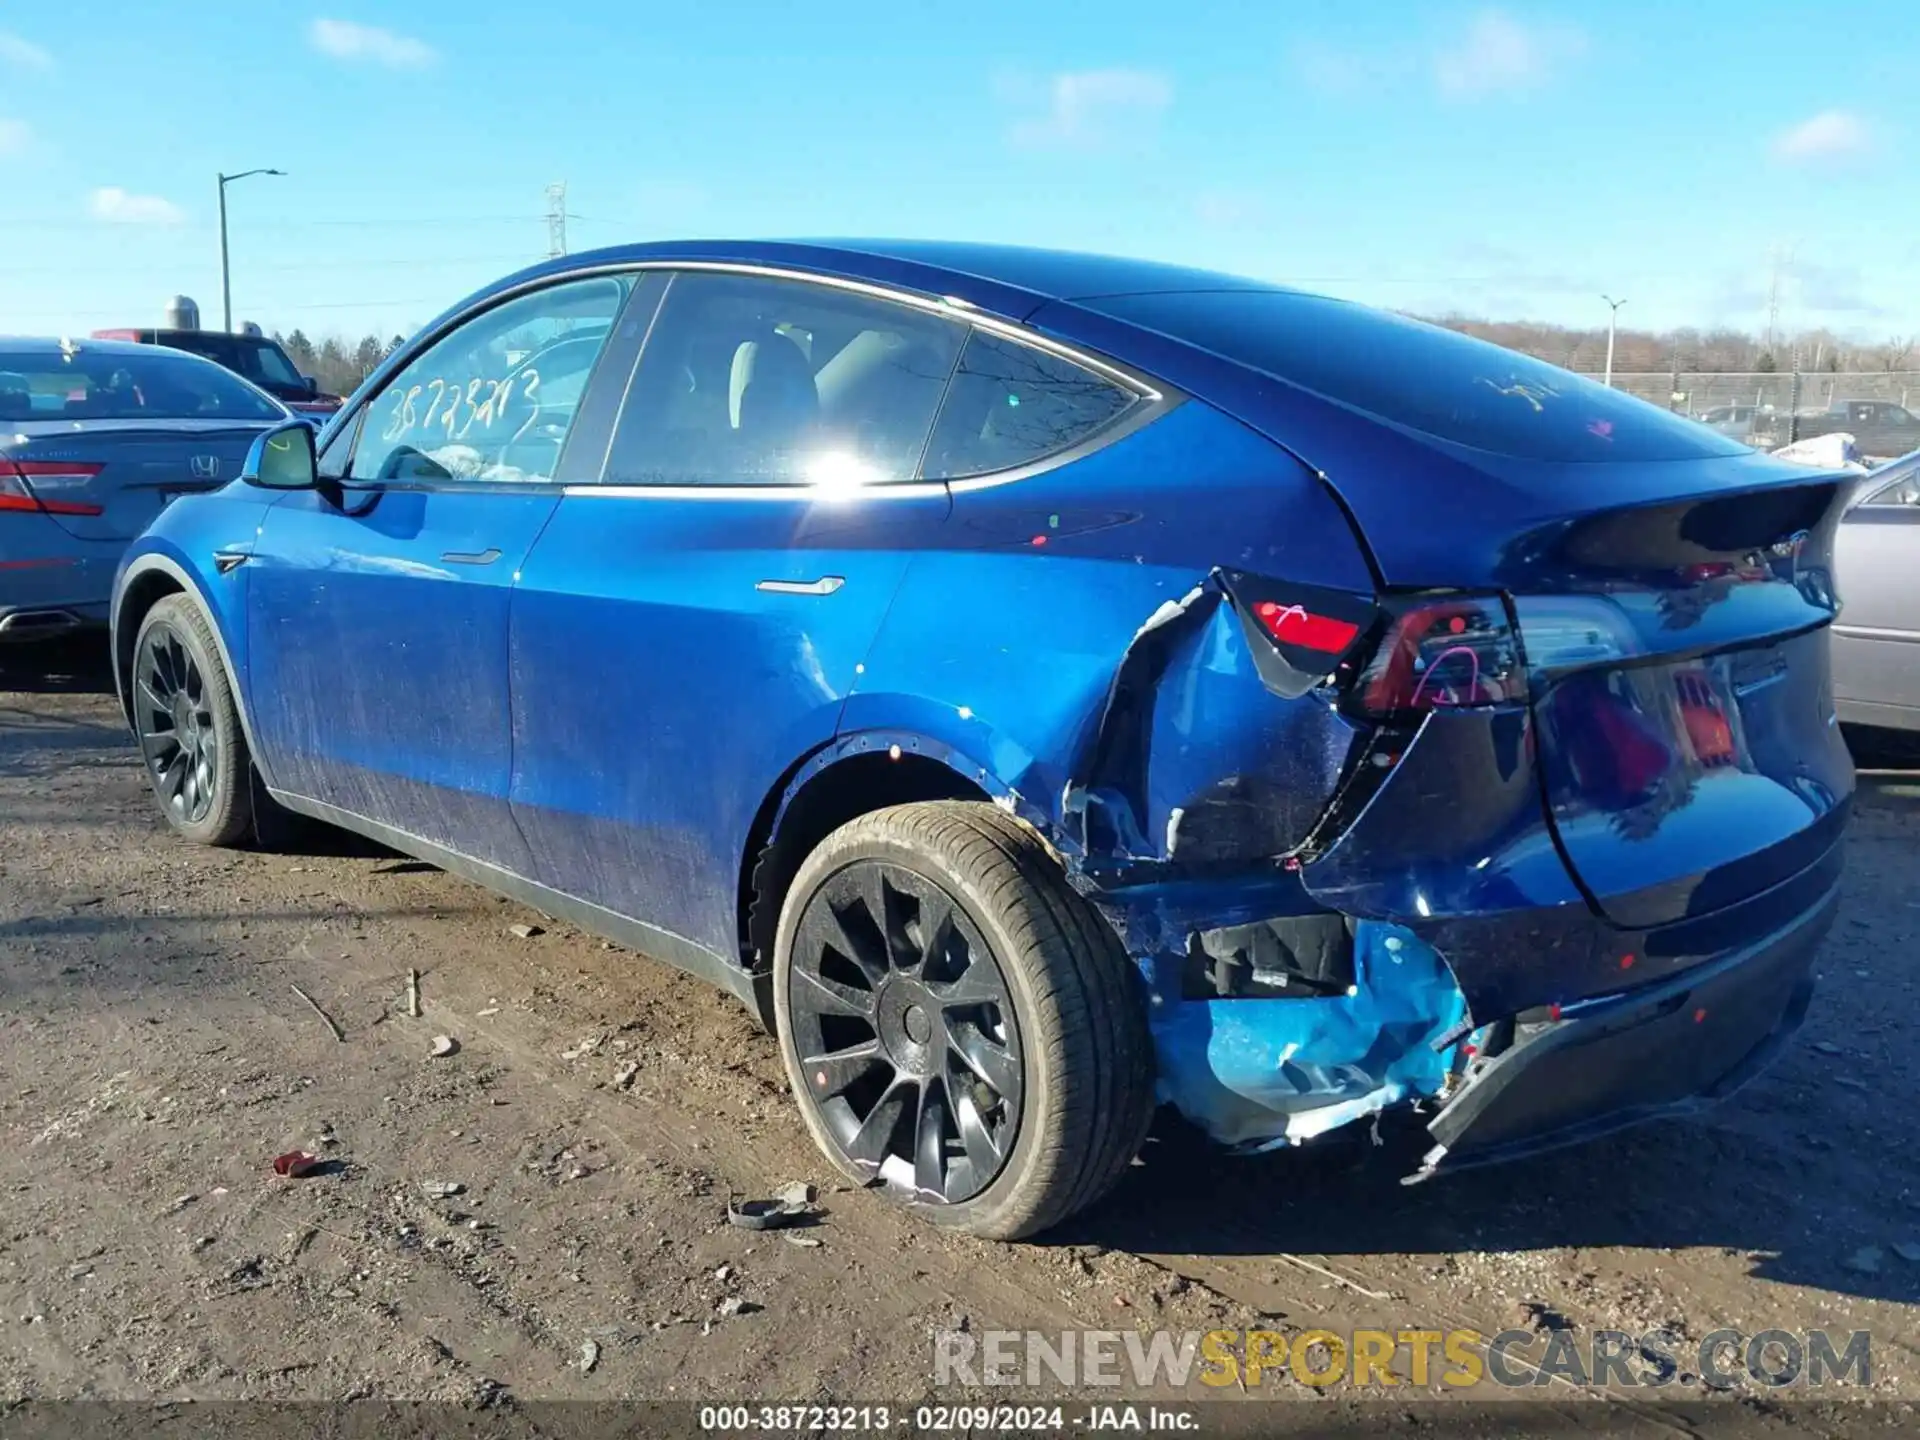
[1356,595,1526,716]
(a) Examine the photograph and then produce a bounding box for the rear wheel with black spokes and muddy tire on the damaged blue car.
[774,801,1154,1240]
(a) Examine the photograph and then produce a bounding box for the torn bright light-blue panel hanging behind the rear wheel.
[1150,920,1467,1148]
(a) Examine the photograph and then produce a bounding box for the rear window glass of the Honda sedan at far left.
[0,346,284,420]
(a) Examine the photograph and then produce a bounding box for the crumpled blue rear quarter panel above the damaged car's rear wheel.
[841,403,1373,862]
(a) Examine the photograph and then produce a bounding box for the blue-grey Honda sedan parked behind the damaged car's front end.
[0,336,288,639]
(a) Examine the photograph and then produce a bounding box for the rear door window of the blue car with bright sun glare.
[605,273,966,488]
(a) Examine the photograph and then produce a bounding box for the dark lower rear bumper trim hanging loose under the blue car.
[1409,889,1839,1179]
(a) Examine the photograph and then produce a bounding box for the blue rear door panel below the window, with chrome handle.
[509,486,950,954]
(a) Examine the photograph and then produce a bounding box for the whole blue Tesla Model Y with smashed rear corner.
[113,242,1853,1236]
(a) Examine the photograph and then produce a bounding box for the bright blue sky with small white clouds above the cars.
[0,0,1920,340]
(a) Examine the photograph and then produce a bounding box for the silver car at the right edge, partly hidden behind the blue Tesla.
[1834,451,1920,733]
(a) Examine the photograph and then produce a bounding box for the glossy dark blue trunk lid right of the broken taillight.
[1513,474,1853,927]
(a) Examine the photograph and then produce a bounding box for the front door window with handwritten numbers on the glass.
[348,275,632,482]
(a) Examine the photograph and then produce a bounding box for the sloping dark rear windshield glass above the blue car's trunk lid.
[1075,290,1745,461]
